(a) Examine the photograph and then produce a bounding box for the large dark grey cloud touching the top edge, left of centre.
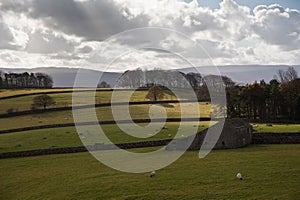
[30,0,147,41]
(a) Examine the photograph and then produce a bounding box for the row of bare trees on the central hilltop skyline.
[117,68,235,101]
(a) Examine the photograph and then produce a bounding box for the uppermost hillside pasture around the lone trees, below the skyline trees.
[0,89,204,114]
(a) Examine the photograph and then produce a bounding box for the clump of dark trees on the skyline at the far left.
[0,71,53,89]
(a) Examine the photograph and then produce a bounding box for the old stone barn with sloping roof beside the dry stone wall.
[167,119,252,150]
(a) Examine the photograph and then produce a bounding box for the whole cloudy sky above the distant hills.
[0,0,300,71]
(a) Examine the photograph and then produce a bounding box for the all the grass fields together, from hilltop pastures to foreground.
[0,89,300,200]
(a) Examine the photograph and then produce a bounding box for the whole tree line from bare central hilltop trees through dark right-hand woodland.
[118,67,300,122]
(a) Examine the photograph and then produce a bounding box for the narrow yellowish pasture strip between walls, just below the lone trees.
[0,103,211,130]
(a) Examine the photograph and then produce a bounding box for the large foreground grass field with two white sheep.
[0,145,300,199]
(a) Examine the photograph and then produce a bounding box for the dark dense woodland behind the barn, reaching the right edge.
[226,67,300,121]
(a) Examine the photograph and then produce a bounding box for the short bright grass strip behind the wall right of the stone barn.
[252,124,300,133]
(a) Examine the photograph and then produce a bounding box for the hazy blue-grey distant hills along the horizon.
[0,65,300,87]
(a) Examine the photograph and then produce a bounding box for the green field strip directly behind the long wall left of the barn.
[0,122,210,153]
